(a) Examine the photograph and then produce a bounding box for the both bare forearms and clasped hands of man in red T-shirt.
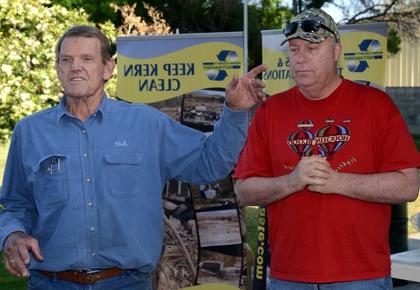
[236,156,420,206]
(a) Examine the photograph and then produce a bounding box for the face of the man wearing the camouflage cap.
[289,37,341,88]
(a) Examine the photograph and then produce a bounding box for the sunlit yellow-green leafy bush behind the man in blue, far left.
[0,0,115,141]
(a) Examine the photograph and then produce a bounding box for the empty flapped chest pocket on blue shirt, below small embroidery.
[104,152,143,198]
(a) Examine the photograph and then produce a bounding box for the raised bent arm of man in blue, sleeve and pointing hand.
[161,65,266,184]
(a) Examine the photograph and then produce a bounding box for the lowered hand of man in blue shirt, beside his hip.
[3,232,44,277]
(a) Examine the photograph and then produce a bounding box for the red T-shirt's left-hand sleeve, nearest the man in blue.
[234,103,272,179]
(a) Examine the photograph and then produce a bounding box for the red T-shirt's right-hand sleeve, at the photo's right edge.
[377,95,420,172]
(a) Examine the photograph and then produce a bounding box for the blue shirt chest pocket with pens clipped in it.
[34,154,69,210]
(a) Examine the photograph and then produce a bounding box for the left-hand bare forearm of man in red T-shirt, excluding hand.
[235,175,295,206]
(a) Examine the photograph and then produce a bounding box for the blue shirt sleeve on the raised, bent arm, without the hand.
[161,106,249,184]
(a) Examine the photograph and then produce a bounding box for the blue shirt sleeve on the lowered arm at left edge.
[0,126,36,249]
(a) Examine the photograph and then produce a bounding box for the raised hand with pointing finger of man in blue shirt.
[226,64,267,110]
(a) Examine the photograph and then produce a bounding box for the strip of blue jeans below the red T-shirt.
[268,277,392,290]
